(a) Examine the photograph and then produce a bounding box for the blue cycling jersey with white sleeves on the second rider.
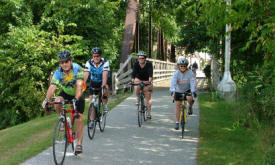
[84,58,110,83]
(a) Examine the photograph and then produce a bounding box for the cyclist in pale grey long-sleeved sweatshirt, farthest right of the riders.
[170,57,197,130]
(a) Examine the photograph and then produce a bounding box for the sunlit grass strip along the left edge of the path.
[0,93,130,165]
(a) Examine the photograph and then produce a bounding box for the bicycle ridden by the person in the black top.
[130,82,151,127]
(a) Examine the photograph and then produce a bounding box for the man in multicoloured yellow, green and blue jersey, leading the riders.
[42,50,85,154]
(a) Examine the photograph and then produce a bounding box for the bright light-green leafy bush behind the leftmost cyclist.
[0,26,85,128]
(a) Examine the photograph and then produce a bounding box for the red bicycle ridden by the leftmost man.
[45,99,79,165]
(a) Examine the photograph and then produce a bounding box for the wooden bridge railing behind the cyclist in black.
[112,55,176,95]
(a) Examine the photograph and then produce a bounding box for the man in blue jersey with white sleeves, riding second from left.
[84,47,110,127]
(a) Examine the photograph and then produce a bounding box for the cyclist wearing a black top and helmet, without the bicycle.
[132,51,153,119]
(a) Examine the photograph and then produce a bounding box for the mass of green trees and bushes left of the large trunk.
[0,0,127,129]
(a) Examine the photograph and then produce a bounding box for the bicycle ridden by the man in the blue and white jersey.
[87,87,107,140]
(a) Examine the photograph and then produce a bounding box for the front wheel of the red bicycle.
[53,118,68,165]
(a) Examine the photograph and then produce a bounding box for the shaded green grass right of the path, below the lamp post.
[198,94,275,165]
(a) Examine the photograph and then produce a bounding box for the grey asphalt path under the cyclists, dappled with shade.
[22,87,199,165]
